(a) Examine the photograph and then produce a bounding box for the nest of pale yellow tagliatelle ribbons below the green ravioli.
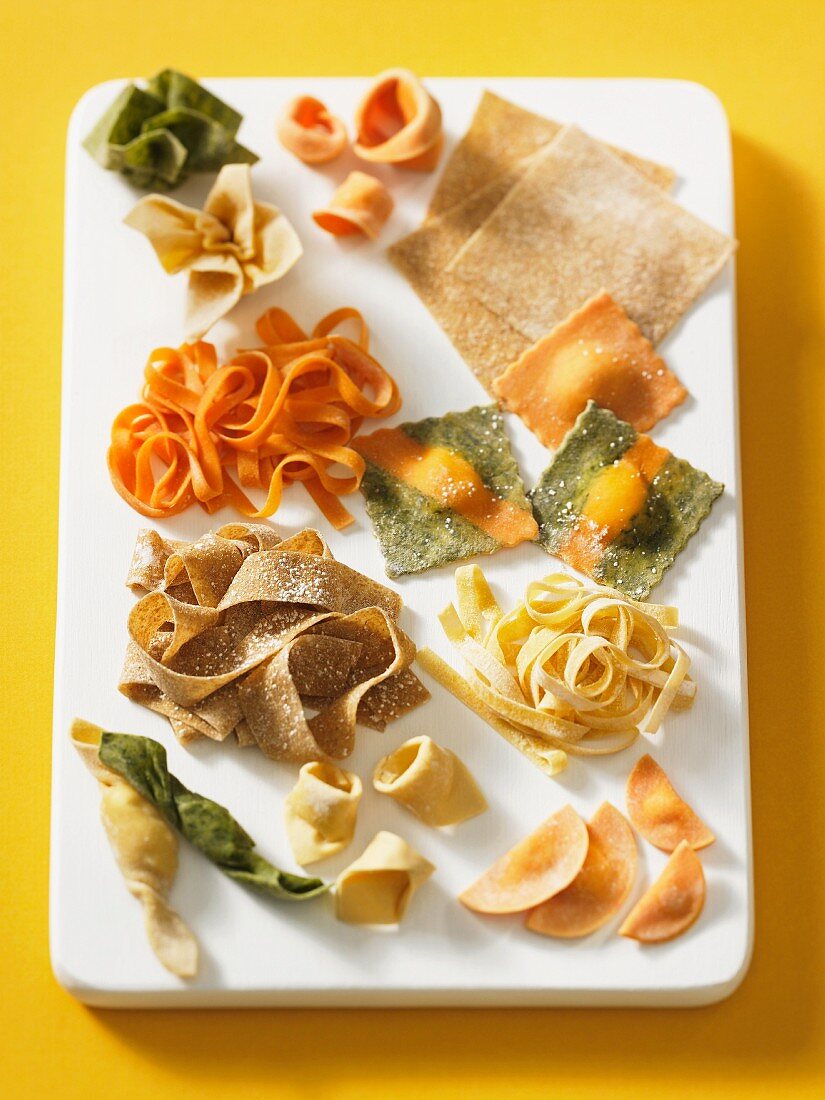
[418,565,695,774]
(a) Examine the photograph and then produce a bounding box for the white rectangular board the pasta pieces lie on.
[51,77,752,1007]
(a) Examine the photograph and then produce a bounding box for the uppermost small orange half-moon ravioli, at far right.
[627,754,715,851]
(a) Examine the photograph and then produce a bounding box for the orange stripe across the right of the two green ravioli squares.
[559,436,670,574]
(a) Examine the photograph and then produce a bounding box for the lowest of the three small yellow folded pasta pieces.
[336,831,436,924]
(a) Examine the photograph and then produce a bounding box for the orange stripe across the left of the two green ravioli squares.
[355,428,537,547]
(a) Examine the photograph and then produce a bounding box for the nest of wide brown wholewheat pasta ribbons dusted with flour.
[124,524,429,763]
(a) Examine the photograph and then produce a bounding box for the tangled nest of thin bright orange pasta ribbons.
[108,307,400,530]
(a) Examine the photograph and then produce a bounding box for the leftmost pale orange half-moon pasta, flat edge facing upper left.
[459,806,589,913]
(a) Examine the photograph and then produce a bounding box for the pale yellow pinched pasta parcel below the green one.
[124,164,304,340]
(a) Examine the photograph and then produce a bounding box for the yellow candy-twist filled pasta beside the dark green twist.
[72,718,198,978]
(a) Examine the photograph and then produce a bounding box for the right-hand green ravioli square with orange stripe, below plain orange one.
[530,402,724,600]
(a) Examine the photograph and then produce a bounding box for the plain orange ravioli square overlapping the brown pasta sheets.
[493,292,688,448]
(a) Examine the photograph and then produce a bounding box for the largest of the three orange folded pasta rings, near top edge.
[353,68,444,172]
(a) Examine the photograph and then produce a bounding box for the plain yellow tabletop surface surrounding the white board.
[0,0,825,1100]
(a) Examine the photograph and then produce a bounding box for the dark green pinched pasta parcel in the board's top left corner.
[84,69,259,190]
